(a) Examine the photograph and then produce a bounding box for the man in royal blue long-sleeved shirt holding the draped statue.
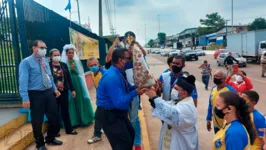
[95,49,145,150]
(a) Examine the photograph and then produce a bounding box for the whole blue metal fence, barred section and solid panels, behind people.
[0,0,106,102]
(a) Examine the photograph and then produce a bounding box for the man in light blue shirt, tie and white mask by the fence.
[19,40,63,150]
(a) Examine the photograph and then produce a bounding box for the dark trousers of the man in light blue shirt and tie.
[29,89,60,148]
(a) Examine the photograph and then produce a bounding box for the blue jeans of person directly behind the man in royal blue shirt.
[129,96,141,146]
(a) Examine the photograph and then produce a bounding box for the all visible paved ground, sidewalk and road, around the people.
[24,54,266,150]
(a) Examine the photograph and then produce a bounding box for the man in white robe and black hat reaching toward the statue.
[146,76,199,150]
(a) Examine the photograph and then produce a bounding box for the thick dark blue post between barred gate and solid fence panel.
[15,0,29,58]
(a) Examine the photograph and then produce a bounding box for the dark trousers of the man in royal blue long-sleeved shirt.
[96,107,135,150]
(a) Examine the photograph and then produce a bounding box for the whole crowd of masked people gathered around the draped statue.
[19,31,266,150]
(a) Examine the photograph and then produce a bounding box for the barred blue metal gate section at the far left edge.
[0,0,20,103]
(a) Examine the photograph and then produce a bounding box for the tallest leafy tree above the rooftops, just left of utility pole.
[200,12,225,29]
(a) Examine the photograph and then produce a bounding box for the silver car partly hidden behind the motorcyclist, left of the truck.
[217,52,247,67]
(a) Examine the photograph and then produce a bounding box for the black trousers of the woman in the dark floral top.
[56,91,73,133]
